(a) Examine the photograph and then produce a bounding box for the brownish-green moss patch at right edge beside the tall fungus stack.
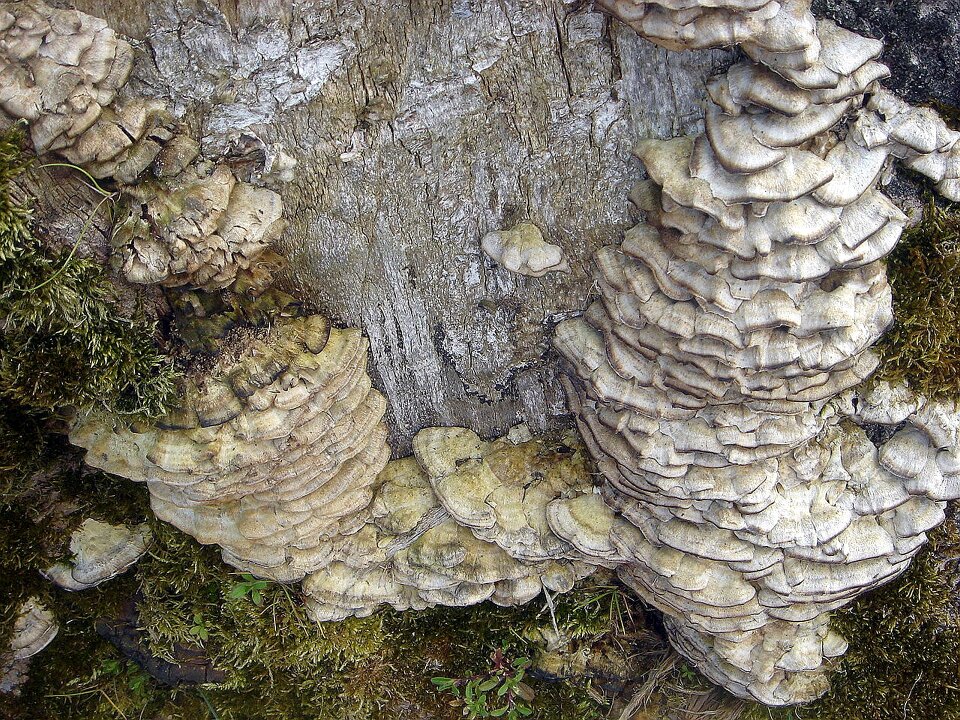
[876,202,960,396]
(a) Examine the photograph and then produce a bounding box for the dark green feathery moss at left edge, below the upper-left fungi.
[0,126,174,422]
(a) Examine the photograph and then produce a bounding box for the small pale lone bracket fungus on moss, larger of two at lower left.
[43,518,150,590]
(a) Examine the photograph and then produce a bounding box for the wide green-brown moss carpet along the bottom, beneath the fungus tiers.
[0,522,662,720]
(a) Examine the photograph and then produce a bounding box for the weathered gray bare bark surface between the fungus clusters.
[56,0,728,455]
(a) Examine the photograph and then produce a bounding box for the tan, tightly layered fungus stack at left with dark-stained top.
[70,316,389,581]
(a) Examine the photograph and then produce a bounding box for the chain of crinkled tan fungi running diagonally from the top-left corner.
[0,2,284,288]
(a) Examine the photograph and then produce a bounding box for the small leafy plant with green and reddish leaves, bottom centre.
[430,648,534,720]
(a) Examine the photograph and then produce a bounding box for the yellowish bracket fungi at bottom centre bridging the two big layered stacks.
[303,427,600,621]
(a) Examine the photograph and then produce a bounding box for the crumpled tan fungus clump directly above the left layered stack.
[113,165,285,290]
